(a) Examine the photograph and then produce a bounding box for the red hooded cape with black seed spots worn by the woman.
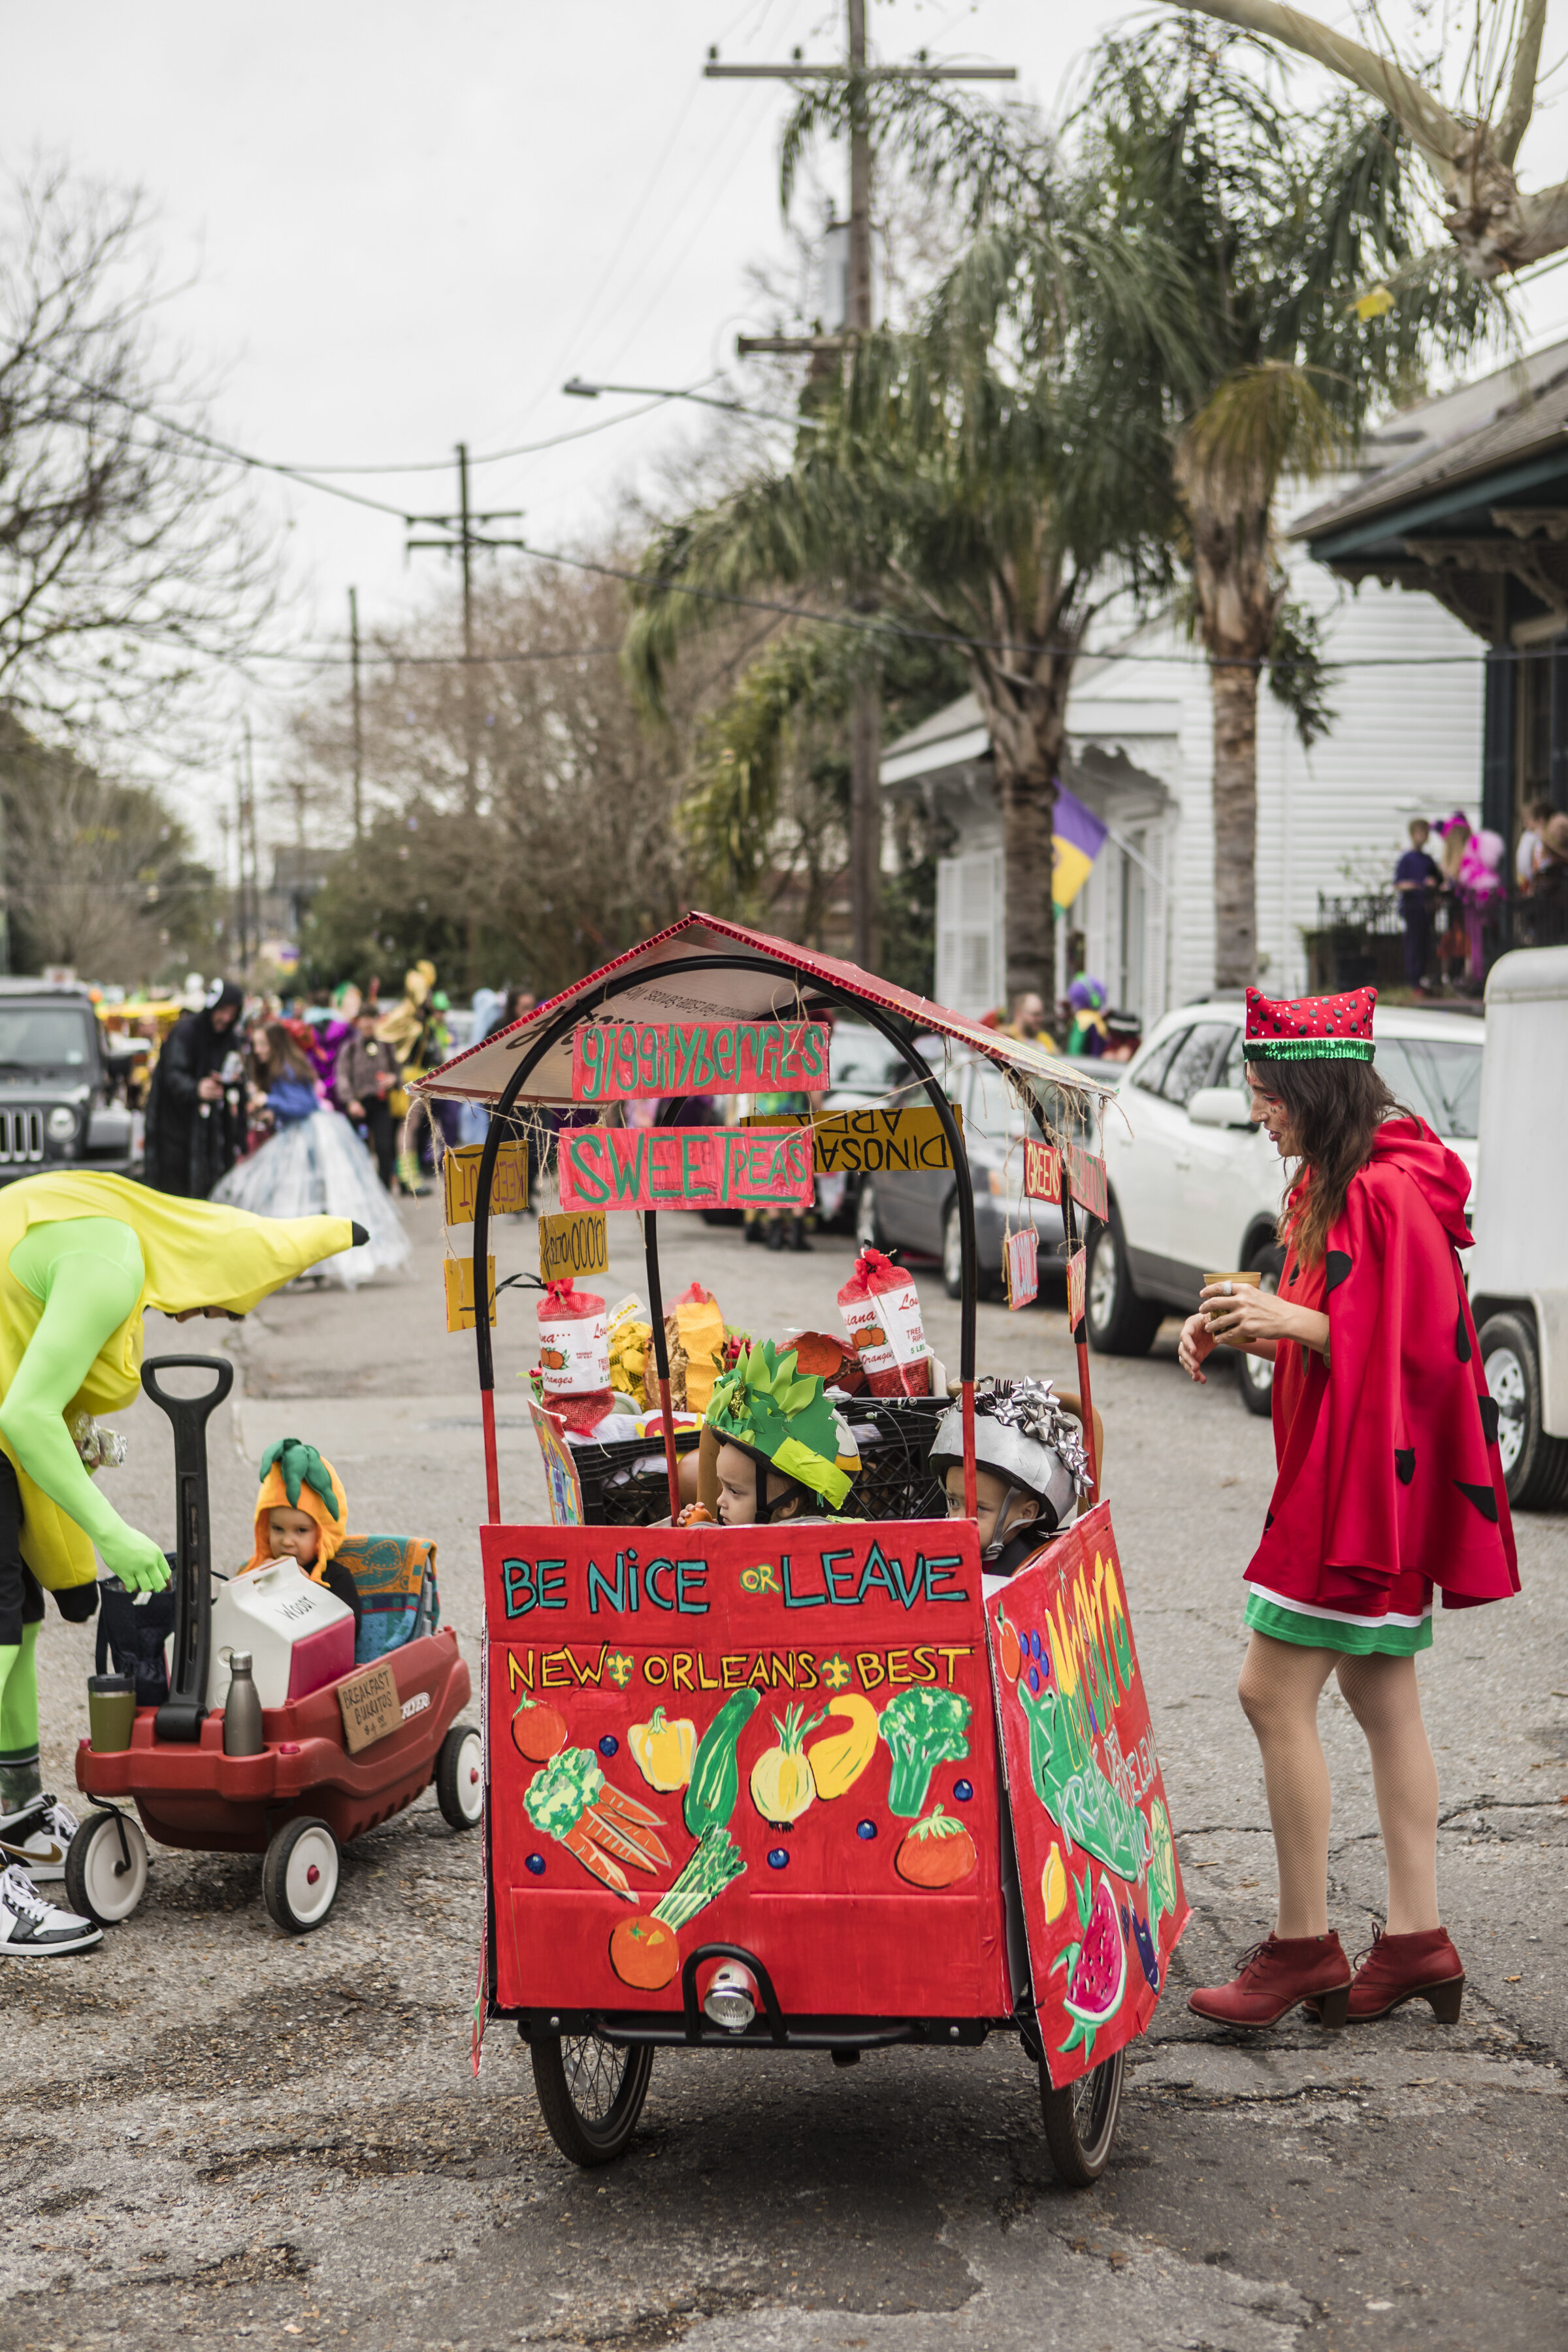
[1246,1120,1518,1614]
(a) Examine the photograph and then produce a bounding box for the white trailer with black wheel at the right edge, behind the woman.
[1469,948,1568,1510]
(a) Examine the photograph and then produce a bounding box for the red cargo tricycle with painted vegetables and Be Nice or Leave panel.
[423,915,1187,2185]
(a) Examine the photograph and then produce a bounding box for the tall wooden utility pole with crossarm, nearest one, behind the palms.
[703,0,1018,972]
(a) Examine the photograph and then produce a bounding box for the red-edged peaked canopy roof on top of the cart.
[414,910,1115,1103]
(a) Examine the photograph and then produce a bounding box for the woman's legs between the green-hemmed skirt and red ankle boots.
[1237,1632,1439,1936]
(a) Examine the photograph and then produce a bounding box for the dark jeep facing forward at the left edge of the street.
[0,981,141,1183]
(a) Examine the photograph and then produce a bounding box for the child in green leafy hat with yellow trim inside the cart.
[698,1341,860,1526]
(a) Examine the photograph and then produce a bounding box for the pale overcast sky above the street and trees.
[0,0,1568,847]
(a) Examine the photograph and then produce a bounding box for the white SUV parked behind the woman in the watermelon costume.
[1086,997,1486,1414]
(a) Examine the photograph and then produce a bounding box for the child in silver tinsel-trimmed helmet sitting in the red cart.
[931,1380,1088,1590]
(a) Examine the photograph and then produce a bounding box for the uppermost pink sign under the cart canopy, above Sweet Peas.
[571,1021,828,1103]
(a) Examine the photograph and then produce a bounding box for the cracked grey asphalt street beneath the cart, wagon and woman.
[0,1200,1568,2352]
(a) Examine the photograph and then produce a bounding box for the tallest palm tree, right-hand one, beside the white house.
[823,37,1497,988]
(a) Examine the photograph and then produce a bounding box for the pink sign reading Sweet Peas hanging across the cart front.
[557,1126,813,1209]
